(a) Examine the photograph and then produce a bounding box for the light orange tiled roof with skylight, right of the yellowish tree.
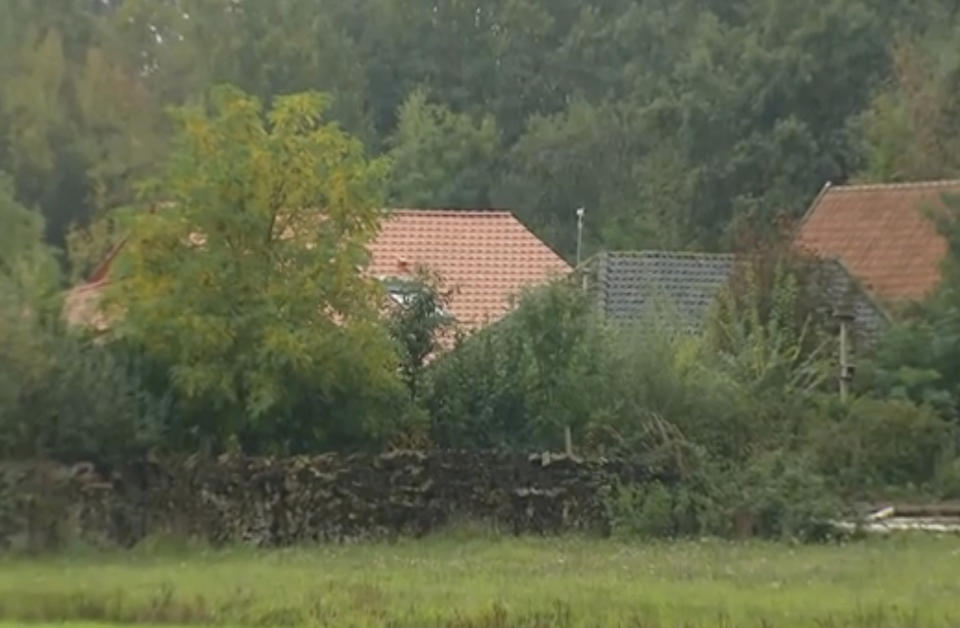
[368,209,572,329]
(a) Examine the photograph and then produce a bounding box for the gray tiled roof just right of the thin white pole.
[589,251,735,327]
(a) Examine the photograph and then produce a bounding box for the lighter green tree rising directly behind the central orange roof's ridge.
[389,91,500,207]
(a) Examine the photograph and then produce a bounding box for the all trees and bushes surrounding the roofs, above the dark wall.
[0,0,960,534]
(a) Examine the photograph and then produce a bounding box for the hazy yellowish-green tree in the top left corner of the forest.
[0,0,164,244]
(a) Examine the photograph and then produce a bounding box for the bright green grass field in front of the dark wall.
[0,534,960,628]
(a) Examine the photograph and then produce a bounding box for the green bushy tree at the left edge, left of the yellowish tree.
[0,176,166,464]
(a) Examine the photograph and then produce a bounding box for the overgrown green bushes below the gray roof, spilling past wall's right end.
[426,250,960,538]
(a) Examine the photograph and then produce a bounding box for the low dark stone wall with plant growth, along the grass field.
[0,451,668,548]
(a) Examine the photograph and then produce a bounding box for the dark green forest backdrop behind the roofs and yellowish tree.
[0,0,960,253]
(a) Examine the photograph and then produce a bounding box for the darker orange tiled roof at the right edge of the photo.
[797,180,960,302]
